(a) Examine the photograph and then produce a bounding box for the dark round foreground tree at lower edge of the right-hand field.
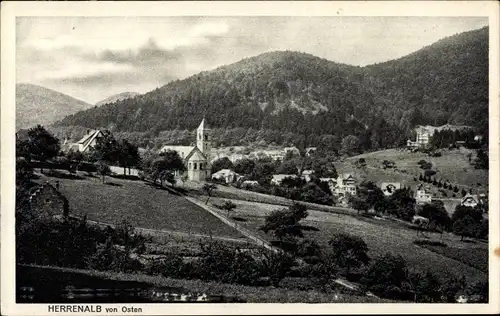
[328,233,370,274]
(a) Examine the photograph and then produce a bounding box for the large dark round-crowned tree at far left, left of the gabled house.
[22,125,61,169]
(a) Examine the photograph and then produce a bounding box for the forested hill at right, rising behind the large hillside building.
[364,27,488,135]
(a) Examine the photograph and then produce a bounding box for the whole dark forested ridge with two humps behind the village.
[58,28,488,147]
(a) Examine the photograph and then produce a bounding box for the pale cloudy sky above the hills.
[16,17,488,104]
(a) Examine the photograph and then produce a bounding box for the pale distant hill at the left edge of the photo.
[16,84,92,130]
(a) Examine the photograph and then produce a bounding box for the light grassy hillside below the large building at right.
[344,148,488,188]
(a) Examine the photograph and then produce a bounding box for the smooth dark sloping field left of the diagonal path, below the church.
[38,175,242,238]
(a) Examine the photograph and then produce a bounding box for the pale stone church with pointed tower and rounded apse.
[159,118,212,181]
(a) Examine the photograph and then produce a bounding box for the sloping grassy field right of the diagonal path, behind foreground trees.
[206,198,488,282]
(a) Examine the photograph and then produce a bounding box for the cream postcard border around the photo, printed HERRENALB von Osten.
[0,1,500,315]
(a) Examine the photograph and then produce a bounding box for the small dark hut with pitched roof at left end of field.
[29,182,69,218]
